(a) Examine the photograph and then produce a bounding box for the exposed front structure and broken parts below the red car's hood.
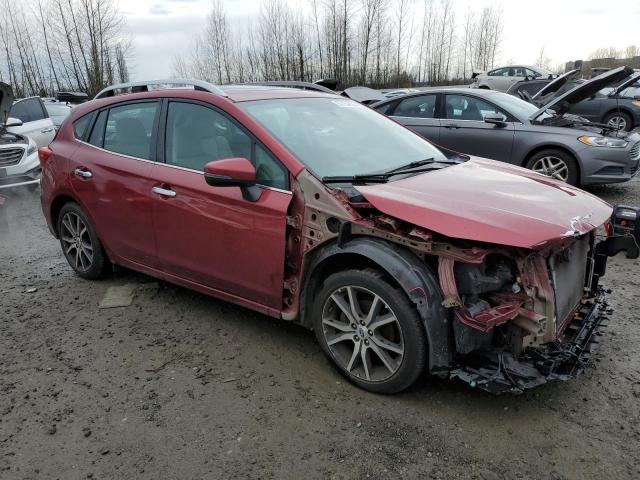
[285,171,638,394]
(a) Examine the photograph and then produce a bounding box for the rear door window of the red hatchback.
[103,102,158,160]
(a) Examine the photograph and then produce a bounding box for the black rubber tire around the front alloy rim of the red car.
[311,269,427,394]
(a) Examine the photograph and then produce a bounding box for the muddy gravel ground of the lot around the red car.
[0,181,640,480]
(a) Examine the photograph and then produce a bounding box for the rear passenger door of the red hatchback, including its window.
[69,100,160,268]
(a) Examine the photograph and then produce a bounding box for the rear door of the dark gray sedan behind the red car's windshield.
[391,94,440,143]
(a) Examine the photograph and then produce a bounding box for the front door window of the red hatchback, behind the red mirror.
[165,102,289,189]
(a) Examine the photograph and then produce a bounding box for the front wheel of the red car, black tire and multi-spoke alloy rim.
[314,270,426,393]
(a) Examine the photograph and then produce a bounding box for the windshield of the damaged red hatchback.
[239,97,446,178]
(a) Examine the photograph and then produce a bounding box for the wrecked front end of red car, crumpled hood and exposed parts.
[285,161,638,394]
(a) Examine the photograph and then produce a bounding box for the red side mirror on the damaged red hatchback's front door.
[204,157,262,202]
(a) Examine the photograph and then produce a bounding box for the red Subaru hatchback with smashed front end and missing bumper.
[40,81,638,393]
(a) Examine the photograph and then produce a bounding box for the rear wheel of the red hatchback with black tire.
[57,202,111,280]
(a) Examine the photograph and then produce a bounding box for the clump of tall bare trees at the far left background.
[0,0,130,97]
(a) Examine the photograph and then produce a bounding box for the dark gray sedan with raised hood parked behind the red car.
[373,72,640,185]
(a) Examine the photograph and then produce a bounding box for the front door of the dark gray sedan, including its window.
[440,94,514,162]
